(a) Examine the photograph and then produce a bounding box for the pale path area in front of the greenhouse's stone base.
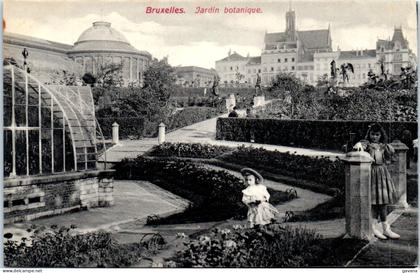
[5,180,189,233]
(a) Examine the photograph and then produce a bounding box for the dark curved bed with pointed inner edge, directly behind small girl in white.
[115,157,294,224]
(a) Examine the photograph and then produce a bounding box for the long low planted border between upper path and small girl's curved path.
[147,143,344,194]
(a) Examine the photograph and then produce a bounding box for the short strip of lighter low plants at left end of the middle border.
[147,143,233,158]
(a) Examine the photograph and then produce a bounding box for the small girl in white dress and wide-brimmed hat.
[241,168,278,228]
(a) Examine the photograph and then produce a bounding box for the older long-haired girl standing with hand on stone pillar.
[354,123,400,240]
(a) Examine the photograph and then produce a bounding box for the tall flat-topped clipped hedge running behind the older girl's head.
[216,118,417,150]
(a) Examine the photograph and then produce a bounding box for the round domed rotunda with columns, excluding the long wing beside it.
[67,22,151,84]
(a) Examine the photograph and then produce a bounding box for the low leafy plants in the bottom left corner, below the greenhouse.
[4,226,142,267]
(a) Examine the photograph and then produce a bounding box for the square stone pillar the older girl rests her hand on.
[343,151,373,240]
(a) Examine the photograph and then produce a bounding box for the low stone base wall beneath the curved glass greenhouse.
[4,170,114,223]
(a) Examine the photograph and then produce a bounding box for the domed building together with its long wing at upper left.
[3,21,152,85]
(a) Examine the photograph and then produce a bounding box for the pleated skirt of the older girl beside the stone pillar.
[371,165,397,205]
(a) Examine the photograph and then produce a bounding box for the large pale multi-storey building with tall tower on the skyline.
[216,9,416,86]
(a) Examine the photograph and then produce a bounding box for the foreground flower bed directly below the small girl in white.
[167,224,367,268]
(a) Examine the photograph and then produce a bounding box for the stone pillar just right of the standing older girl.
[388,140,409,208]
